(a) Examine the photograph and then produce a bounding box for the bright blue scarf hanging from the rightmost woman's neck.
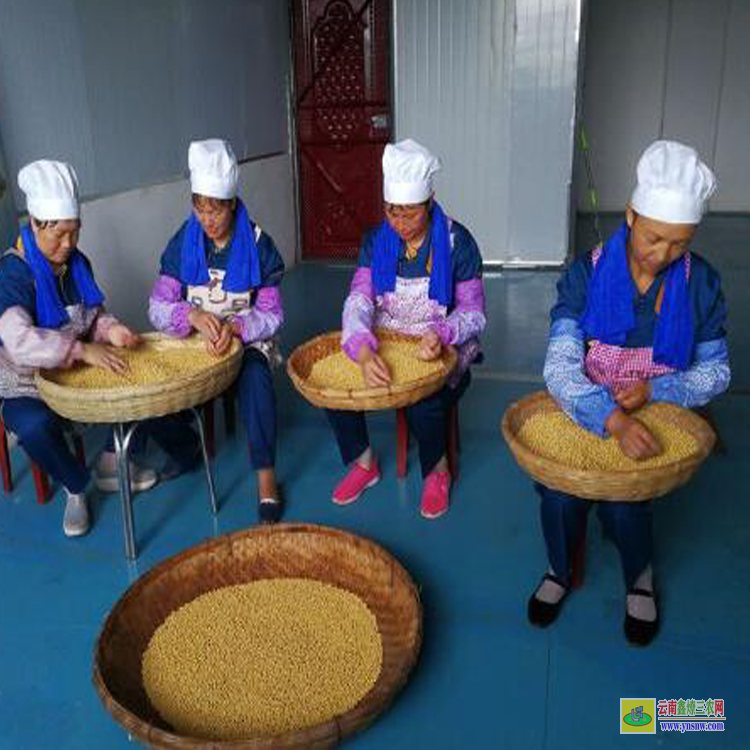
[579,223,695,370]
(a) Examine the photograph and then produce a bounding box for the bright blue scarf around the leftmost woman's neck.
[21,225,104,328]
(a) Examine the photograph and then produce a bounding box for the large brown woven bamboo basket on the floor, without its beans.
[93,524,422,750]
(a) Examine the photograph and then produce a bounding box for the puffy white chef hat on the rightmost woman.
[630,141,716,224]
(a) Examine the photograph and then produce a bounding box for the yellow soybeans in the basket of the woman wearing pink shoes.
[308,339,444,390]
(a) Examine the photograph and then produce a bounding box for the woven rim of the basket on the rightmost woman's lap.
[501,391,716,490]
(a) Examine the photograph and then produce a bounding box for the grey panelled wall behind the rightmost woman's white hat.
[576,0,750,212]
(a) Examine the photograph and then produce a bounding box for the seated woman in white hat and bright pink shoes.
[328,140,486,518]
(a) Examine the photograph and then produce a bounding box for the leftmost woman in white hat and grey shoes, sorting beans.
[0,160,157,536]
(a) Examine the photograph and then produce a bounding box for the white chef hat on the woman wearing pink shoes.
[383,138,440,205]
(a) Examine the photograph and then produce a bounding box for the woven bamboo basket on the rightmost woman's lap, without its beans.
[502,391,716,501]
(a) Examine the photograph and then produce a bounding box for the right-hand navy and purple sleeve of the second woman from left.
[232,232,284,344]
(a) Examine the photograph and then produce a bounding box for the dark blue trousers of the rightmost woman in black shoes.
[534,484,653,589]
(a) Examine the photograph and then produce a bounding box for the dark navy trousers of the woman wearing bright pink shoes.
[326,370,471,477]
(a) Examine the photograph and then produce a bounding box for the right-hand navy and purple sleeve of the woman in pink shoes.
[433,222,487,346]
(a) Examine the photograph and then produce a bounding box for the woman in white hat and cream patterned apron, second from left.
[149,139,284,523]
